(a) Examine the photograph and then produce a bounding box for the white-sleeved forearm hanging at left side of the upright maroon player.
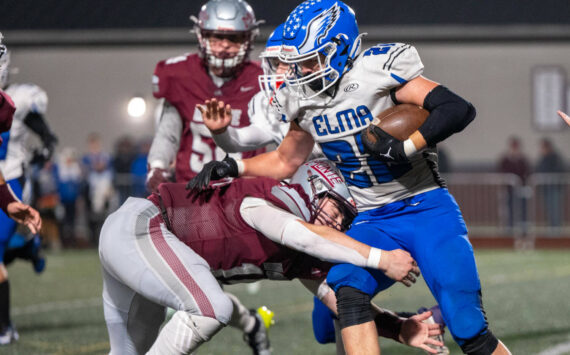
[148,103,182,169]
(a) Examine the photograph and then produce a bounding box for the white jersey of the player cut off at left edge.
[0,84,48,180]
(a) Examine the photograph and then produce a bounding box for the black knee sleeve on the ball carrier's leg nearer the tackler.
[336,287,373,329]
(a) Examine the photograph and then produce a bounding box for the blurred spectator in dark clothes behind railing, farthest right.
[536,138,566,227]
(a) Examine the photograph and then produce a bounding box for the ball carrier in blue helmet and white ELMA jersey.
[189,0,509,355]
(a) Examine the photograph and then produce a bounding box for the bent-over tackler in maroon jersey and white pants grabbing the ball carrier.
[99,160,441,355]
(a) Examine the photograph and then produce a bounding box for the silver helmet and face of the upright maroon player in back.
[190,0,260,77]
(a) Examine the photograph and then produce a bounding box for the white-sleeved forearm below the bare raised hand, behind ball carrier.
[212,125,273,153]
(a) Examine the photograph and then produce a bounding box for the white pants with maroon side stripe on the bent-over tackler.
[99,198,233,355]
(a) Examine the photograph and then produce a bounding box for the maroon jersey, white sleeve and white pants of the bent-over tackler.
[99,178,367,354]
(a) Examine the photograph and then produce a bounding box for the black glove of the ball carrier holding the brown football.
[362,124,409,163]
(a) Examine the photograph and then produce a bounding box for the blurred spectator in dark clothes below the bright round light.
[113,136,135,204]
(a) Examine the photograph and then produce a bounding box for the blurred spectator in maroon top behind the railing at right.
[498,136,530,231]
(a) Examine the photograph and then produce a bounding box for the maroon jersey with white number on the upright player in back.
[153,54,264,182]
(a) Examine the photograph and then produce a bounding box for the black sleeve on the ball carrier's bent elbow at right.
[419,85,476,146]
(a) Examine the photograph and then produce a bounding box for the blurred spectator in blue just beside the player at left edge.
[33,159,61,250]
